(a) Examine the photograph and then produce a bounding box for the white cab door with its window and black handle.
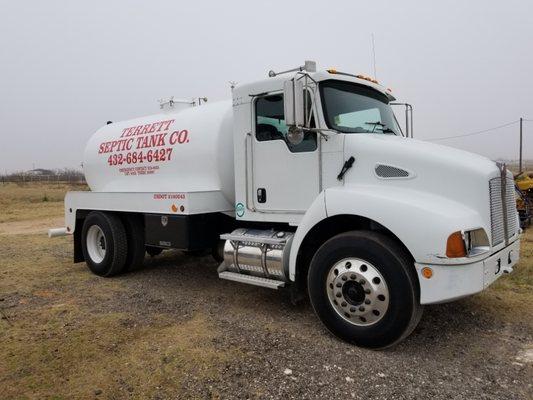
[248,93,319,213]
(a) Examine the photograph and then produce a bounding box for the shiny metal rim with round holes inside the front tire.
[326,258,389,326]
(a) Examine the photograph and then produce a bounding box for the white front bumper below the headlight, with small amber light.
[415,239,520,304]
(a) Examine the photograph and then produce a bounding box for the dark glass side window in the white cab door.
[255,94,317,153]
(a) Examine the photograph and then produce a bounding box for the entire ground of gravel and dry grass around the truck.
[0,185,533,400]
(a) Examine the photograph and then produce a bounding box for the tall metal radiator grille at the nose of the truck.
[489,177,518,246]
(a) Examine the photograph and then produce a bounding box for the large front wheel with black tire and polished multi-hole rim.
[308,231,423,349]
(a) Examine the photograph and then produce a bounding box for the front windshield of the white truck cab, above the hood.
[320,81,400,135]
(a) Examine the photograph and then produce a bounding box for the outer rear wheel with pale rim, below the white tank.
[81,211,128,277]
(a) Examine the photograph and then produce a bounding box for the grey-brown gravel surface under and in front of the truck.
[82,252,533,399]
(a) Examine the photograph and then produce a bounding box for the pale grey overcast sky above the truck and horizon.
[0,0,533,172]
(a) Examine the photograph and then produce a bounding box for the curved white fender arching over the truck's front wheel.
[289,185,490,280]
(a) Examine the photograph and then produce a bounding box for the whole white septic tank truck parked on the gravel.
[50,62,520,348]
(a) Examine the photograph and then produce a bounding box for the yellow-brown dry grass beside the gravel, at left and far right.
[0,185,533,399]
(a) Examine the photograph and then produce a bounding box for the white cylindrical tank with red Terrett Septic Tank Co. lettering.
[83,101,235,204]
